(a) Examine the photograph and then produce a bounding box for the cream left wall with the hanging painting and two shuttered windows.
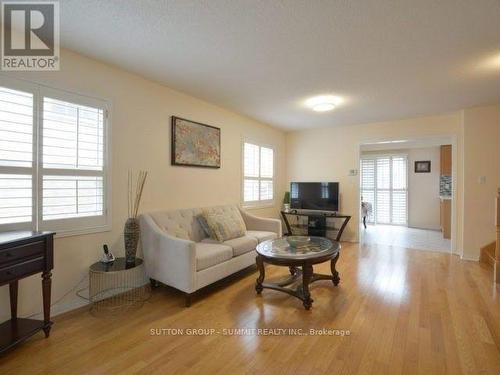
[0,51,285,321]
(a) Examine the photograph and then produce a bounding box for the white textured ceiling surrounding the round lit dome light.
[61,0,500,130]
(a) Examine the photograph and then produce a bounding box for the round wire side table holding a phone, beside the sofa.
[89,258,151,314]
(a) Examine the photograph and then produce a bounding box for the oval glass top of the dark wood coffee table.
[256,236,340,259]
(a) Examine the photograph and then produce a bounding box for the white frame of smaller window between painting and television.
[240,137,276,209]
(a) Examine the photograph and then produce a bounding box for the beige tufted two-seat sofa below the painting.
[140,205,282,306]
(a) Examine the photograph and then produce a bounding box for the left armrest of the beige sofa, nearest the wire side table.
[139,215,196,293]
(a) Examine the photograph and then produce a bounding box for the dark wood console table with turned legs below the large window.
[0,231,55,354]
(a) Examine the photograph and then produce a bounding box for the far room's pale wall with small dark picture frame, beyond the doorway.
[362,147,441,230]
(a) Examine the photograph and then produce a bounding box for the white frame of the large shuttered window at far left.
[0,74,112,237]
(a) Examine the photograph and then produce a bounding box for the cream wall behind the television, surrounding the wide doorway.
[286,112,463,254]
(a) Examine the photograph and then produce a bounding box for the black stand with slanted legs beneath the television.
[281,210,351,241]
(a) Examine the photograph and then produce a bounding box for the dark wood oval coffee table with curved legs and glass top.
[255,237,340,310]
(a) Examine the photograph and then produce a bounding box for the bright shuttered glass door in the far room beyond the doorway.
[360,155,408,225]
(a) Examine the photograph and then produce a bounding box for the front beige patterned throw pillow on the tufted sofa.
[203,210,246,242]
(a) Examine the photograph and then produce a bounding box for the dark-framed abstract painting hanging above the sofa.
[171,116,220,168]
